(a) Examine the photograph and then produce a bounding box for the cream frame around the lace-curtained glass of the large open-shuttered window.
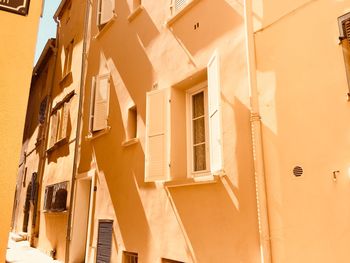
[186,81,211,178]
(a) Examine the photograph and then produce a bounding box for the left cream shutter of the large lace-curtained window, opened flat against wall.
[145,89,170,182]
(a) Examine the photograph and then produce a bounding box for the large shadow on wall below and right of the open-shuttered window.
[168,99,260,263]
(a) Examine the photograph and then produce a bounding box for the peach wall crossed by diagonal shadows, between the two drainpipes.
[79,0,260,263]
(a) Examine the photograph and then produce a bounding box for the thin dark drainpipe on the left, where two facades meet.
[65,0,90,263]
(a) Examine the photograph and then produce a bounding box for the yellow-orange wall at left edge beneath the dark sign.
[0,1,42,260]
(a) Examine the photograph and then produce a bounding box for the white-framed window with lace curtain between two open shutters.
[186,83,209,176]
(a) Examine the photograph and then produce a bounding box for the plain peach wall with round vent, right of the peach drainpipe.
[254,0,350,262]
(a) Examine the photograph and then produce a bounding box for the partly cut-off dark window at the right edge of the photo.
[338,13,350,95]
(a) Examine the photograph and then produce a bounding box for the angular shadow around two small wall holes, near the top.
[170,0,243,55]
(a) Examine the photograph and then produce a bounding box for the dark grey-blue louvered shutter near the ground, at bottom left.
[96,220,113,263]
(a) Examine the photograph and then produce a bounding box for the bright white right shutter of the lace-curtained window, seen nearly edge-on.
[207,53,223,174]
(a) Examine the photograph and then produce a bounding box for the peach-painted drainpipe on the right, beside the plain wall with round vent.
[244,0,272,263]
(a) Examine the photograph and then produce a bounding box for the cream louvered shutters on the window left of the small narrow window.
[89,74,110,134]
